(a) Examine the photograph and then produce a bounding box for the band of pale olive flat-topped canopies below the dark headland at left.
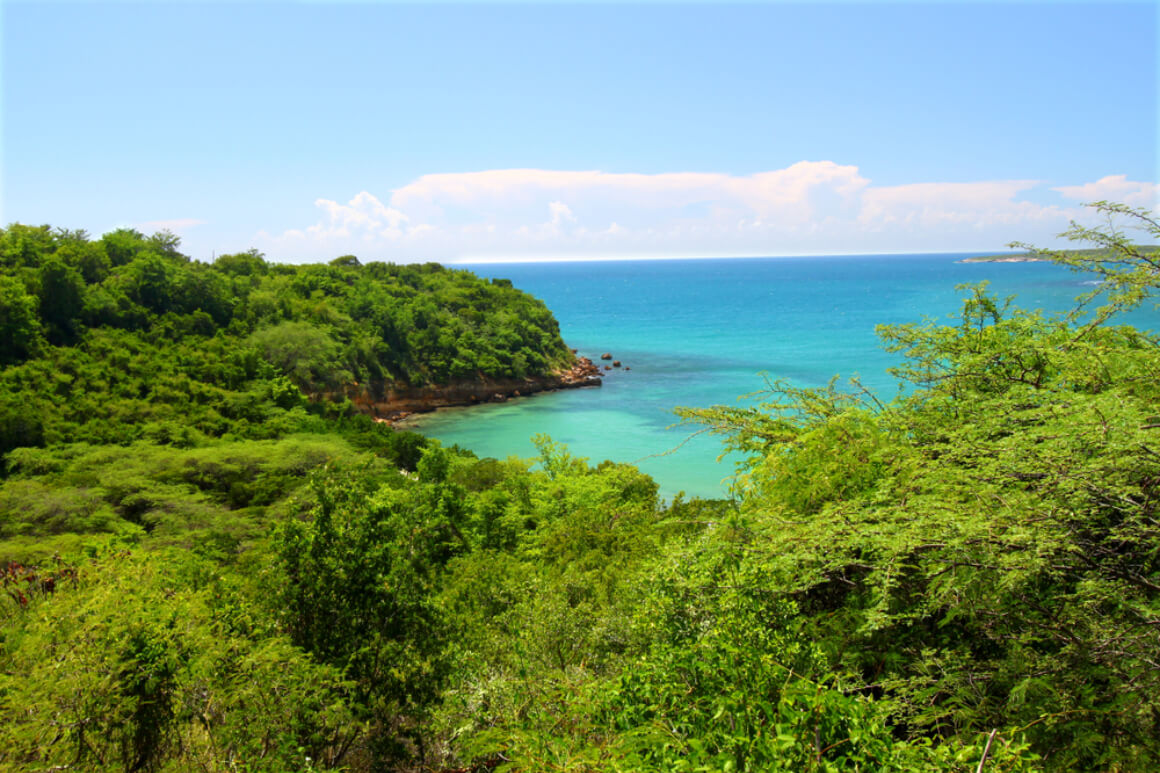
[0,435,360,561]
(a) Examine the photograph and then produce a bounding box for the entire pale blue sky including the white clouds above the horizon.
[0,0,1160,262]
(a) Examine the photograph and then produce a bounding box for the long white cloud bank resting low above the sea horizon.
[255,161,1160,262]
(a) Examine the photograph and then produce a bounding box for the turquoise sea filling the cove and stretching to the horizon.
[412,254,1160,498]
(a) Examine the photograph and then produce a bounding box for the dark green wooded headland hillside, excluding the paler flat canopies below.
[0,225,573,445]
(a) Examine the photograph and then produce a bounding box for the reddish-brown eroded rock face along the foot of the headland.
[347,357,602,421]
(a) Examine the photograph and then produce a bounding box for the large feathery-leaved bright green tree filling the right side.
[686,201,1160,770]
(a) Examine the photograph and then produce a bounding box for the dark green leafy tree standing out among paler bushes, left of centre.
[274,448,466,765]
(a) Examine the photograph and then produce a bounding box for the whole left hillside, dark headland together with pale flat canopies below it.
[0,225,573,558]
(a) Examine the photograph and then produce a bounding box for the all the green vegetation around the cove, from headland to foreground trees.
[0,203,1160,773]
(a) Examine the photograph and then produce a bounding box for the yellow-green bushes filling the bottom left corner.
[0,545,364,772]
